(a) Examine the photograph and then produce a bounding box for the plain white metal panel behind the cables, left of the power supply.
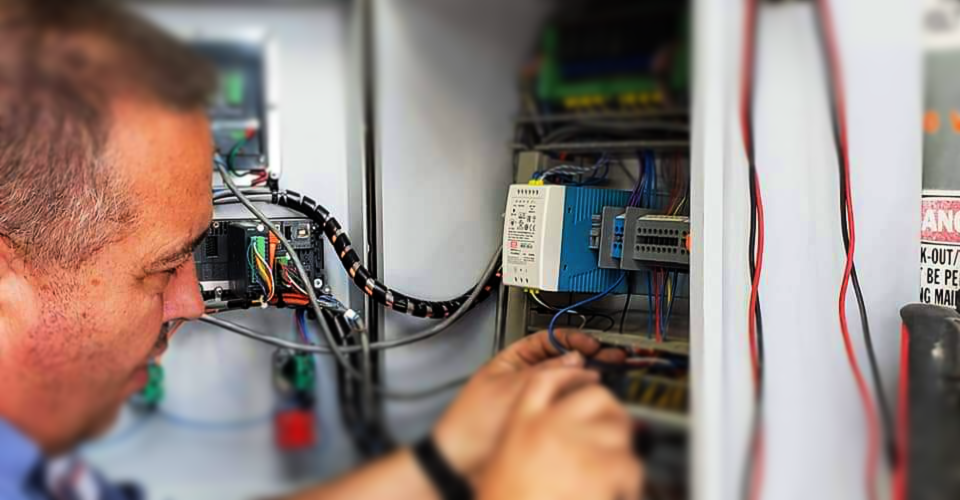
[376,0,542,439]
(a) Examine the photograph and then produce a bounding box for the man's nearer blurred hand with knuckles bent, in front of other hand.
[477,367,643,500]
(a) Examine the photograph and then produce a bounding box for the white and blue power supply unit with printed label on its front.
[503,184,630,293]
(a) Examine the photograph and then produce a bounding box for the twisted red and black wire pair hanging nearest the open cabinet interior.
[740,0,764,499]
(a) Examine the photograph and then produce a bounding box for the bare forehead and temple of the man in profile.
[107,102,213,250]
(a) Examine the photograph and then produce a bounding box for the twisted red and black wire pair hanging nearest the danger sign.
[816,0,884,499]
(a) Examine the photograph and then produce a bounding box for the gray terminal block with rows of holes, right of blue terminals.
[622,208,690,270]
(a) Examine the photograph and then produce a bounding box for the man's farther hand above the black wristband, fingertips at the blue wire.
[433,330,626,479]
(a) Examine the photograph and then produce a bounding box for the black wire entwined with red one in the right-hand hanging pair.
[816,2,897,466]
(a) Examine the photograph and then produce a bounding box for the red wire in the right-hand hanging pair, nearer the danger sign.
[818,0,880,499]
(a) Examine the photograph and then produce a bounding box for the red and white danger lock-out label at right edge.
[920,192,960,307]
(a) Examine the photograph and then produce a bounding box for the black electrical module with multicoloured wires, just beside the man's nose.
[194,218,325,310]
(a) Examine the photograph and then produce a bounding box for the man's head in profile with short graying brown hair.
[0,0,215,452]
